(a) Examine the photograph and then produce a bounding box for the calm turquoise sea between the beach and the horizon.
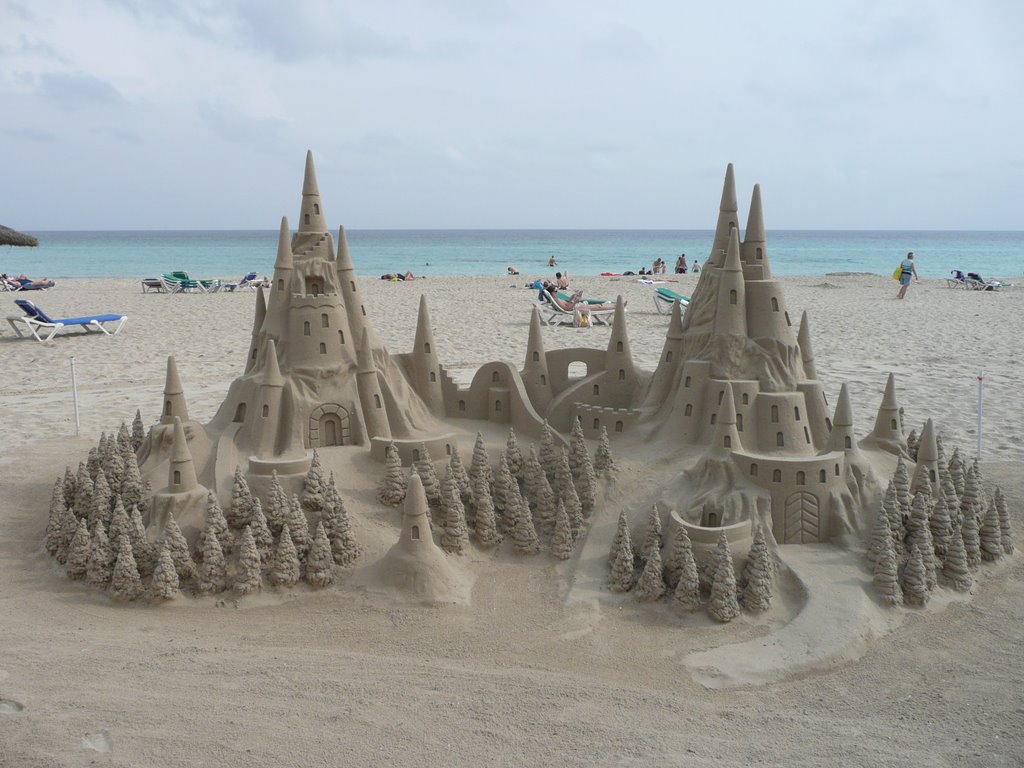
[0,229,1024,286]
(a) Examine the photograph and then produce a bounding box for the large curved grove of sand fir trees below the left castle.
[46,423,360,601]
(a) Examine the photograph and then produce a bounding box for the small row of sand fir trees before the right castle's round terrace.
[607,506,775,622]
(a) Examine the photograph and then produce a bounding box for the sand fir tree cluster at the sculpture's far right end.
[867,440,1014,605]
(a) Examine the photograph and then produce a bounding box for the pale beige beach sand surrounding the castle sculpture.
[0,274,1024,766]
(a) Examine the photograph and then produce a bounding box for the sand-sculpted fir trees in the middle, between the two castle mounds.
[377,419,614,559]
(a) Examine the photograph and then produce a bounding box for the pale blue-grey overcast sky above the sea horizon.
[0,0,1024,230]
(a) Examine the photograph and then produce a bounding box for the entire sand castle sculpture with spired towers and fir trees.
[37,155,1014,623]
